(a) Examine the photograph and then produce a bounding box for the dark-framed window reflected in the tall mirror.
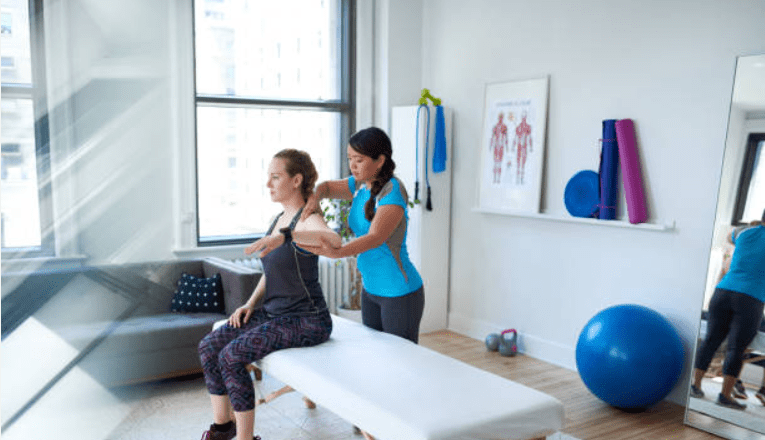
[733,133,765,225]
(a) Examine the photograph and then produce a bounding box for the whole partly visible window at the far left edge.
[0,0,54,258]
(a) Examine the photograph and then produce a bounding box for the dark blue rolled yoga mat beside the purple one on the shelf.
[598,119,619,220]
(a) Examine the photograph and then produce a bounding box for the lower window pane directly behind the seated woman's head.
[197,106,340,241]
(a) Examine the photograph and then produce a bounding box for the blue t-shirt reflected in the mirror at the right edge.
[717,226,765,302]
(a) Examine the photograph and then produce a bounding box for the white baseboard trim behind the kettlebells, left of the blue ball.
[448,313,576,371]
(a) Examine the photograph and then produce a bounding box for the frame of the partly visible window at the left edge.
[0,0,56,259]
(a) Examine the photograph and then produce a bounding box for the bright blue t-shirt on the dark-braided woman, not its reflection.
[348,176,422,297]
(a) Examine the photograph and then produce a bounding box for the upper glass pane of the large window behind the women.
[195,0,341,100]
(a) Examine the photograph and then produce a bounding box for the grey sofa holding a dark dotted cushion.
[2,257,261,386]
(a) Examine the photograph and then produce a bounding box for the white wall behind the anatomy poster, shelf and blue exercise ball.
[412,0,765,401]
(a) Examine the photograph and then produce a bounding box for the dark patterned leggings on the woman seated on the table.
[199,310,332,412]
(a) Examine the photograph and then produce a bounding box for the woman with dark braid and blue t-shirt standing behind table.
[302,127,425,343]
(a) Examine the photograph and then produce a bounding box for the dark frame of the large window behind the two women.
[191,0,356,247]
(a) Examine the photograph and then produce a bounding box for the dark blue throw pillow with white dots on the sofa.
[170,272,225,313]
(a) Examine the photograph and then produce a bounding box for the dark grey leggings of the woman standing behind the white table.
[361,287,425,344]
